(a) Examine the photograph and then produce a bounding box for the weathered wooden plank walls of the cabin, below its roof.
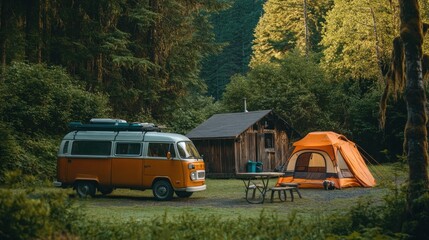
[193,118,289,177]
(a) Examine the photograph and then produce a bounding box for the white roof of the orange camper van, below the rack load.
[63,131,190,142]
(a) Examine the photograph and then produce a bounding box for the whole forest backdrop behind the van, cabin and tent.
[0,0,429,181]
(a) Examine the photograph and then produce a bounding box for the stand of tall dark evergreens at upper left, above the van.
[0,0,224,121]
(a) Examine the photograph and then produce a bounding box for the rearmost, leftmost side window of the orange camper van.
[71,141,112,156]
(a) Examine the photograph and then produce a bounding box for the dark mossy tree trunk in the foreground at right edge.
[399,0,429,219]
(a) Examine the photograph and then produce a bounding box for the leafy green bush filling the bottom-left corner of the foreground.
[0,189,79,239]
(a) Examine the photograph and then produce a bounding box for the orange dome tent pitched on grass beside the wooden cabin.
[278,132,375,188]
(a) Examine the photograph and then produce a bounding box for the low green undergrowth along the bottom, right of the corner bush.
[69,202,407,239]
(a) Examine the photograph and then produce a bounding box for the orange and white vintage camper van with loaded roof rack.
[54,119,206,200]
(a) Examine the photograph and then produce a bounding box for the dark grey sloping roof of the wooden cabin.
[186,110,271,139]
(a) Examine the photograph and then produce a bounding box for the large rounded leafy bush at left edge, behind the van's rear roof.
[0,63,108,136]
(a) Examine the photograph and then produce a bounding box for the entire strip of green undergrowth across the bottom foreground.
[0,185,429,240]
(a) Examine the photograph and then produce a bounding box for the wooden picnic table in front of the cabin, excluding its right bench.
[236,172,284,203]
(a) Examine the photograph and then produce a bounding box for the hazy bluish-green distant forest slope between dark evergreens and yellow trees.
[201,0,264,99]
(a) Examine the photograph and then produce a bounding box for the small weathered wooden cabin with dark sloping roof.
[187,110,293,177]
